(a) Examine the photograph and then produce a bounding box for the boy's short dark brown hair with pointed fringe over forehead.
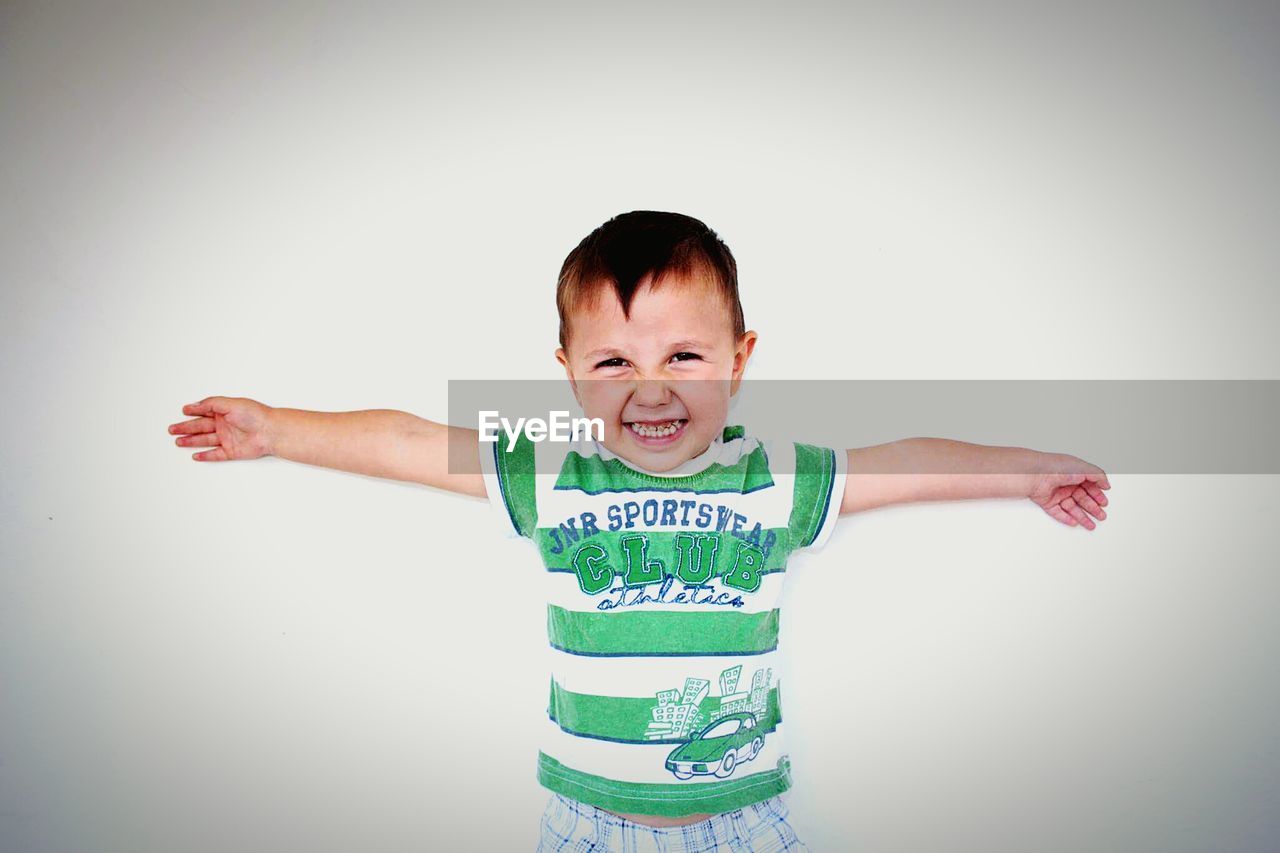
[556,210,746,347]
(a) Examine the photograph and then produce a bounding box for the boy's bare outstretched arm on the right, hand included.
[840,438,1111,530]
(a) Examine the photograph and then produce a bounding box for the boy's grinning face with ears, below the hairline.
[556,277,756,473]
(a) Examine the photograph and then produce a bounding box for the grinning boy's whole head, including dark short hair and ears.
[556,210,756,471]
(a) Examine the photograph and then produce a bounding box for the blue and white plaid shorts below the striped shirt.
[538,793,809,853]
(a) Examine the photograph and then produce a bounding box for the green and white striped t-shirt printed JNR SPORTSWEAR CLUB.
[480,427,846,817]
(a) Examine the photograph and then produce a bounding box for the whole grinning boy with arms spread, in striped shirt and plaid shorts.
[169,211,1110,850]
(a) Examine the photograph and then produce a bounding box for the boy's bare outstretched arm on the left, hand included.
[169,397,485,498]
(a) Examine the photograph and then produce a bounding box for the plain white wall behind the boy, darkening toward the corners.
[0,1,1280,853]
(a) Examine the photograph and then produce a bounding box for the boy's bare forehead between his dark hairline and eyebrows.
[568,277,732,351]
